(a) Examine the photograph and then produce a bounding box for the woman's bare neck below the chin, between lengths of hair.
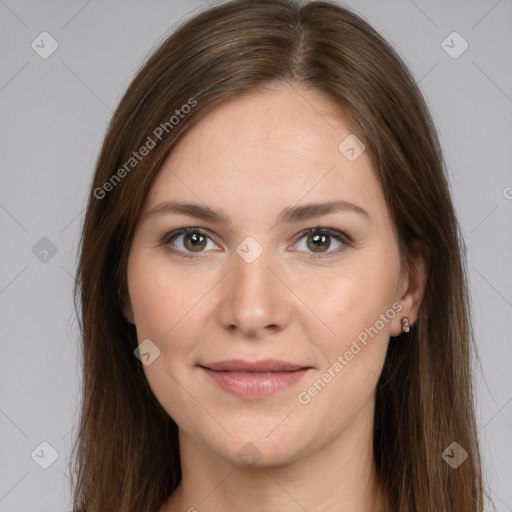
[160,400,387,512]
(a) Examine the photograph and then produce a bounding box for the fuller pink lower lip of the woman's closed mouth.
[201,366,308,398]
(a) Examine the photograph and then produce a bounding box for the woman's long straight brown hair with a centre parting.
[72,0,484,512]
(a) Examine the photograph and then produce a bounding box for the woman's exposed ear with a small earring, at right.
[391,245,430,336]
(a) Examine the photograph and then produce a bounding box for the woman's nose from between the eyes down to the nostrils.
[221,237,291,334]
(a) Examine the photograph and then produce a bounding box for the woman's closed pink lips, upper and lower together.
[199,359,311,398]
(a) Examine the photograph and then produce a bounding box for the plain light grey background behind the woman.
[0,0,512,512]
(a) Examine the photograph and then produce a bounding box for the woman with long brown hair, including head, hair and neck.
[74,0,483,512]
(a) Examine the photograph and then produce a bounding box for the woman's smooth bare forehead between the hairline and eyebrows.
[147,86,386,230]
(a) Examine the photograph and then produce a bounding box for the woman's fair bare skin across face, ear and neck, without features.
[125,85,426,512]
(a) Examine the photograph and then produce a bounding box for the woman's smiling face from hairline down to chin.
[125,86,422,466]
